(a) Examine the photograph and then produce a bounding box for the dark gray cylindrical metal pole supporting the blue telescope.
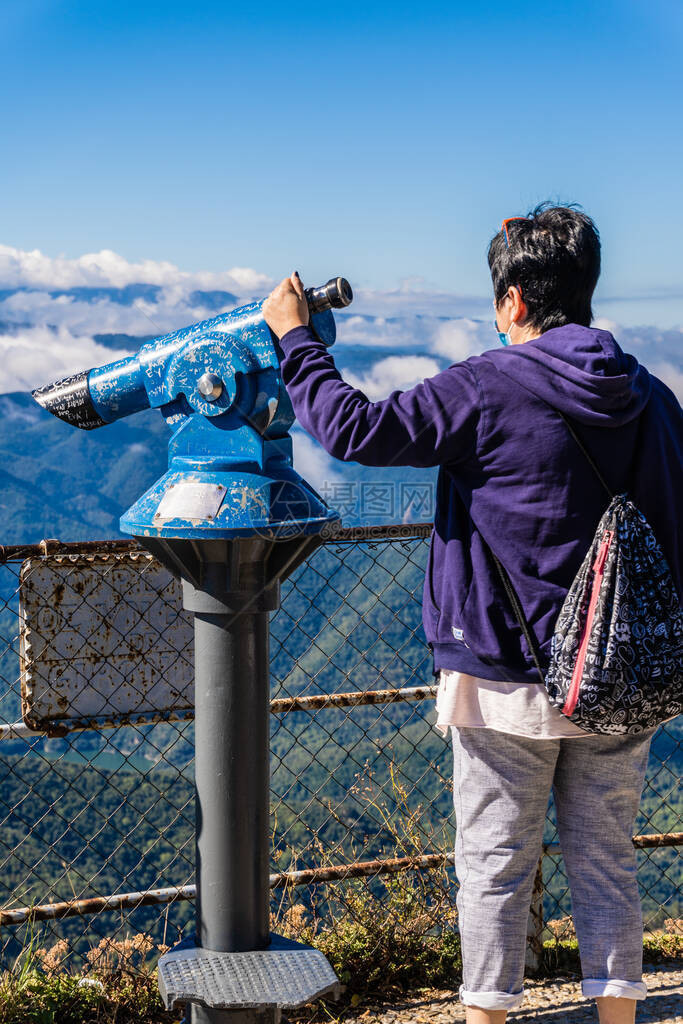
[184,569,280,1024]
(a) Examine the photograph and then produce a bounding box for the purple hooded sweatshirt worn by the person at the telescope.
[281,324,683,682]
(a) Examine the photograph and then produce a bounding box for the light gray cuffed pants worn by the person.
[452,726,654,1010]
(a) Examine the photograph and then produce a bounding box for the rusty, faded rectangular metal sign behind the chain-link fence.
[19,552,195,735]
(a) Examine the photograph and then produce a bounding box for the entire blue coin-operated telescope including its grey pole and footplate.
[34,278,352,1024]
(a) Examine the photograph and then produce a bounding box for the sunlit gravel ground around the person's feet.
[335,963,683,1024]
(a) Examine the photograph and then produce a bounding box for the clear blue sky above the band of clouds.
[0,0,683,326]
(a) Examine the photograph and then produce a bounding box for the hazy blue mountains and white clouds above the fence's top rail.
[0,246,683,544]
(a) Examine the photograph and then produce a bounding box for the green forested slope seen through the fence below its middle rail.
[0,724,683,962]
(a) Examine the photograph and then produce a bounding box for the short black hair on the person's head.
[488,203,600,332]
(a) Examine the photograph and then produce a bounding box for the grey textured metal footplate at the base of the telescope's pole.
[159,935,339,1010]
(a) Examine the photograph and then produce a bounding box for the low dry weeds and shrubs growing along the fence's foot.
[0,917,683,1024]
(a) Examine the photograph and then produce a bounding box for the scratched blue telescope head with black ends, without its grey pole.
[33,278,353,540]
